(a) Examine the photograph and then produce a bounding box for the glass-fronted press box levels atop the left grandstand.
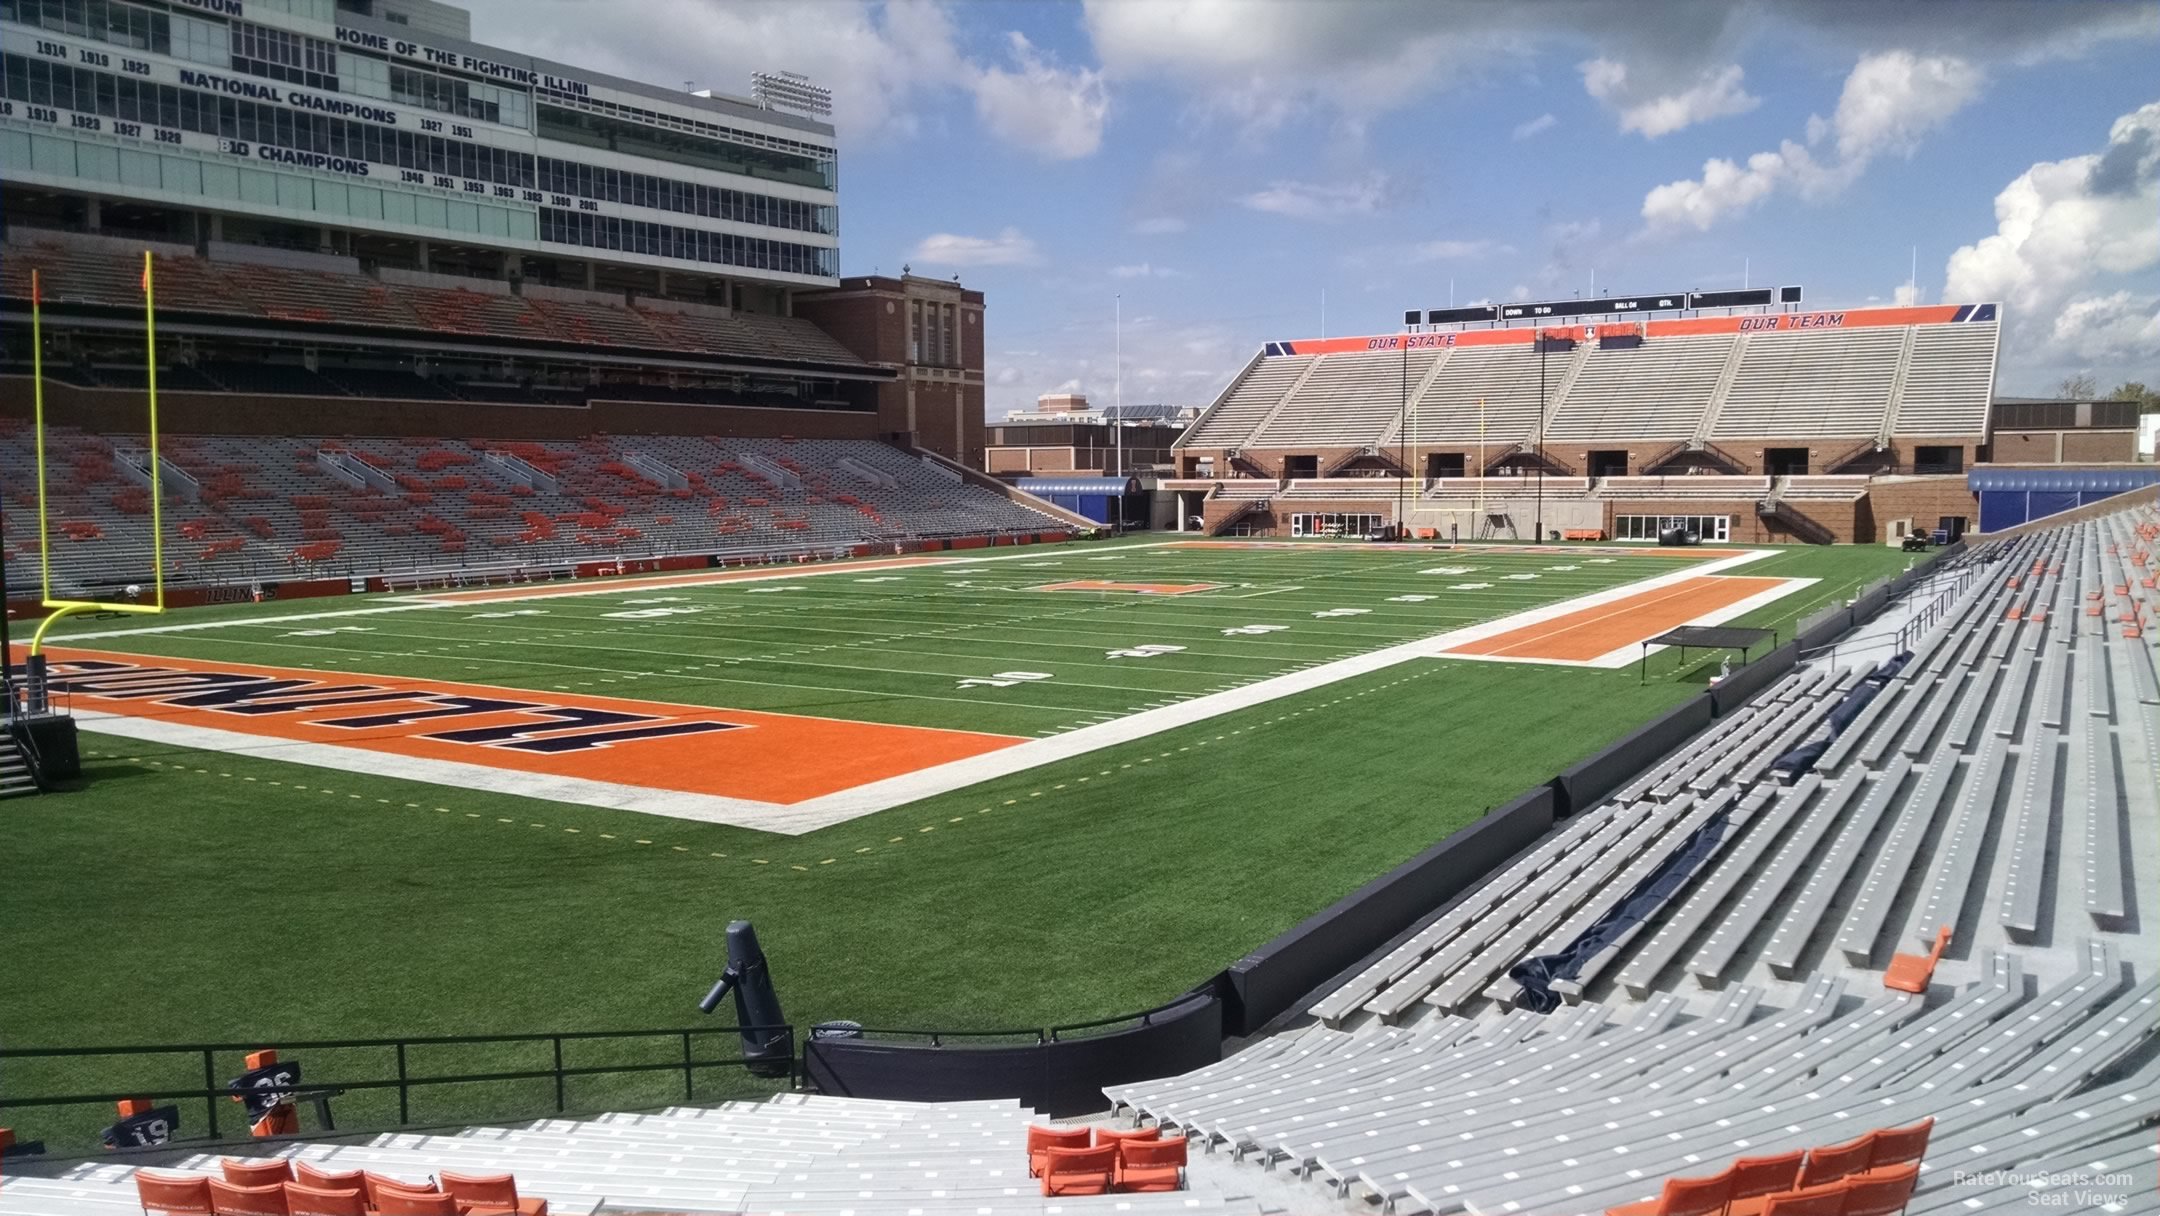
[0,0,838,280]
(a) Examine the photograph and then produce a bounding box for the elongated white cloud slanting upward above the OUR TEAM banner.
[1642,50,1983,233]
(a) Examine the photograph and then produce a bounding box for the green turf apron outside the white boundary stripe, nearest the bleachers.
[0,546,1907,1140]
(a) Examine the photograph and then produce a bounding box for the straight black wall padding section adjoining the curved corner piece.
[1223,786,1553,1037]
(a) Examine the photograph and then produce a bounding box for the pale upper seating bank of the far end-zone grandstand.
[1177,322,1998,449]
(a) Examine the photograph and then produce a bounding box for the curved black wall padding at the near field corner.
[804,991,1223,1117]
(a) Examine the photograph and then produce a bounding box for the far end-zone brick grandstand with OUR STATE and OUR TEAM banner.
[1162,287,2132,542]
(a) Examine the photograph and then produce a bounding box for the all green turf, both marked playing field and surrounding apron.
[0,535,1907,1130]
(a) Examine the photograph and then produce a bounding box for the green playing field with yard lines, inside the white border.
[50,542,1756,737]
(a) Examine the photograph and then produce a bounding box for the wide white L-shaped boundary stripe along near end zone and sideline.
[76,546,1801,836]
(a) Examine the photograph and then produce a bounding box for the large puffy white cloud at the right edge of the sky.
[1944,102,2160,380]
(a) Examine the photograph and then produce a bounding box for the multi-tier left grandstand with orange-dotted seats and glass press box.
[0,0,1062,598]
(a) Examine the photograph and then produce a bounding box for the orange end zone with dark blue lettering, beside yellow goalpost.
[31,648,1024,803]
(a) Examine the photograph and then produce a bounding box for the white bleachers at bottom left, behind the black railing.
[0,1093,1259,1216]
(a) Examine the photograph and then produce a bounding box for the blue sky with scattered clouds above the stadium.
[460,0,2160,417]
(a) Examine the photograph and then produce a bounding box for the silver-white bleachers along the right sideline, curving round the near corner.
[1108,501,2160,1212]
